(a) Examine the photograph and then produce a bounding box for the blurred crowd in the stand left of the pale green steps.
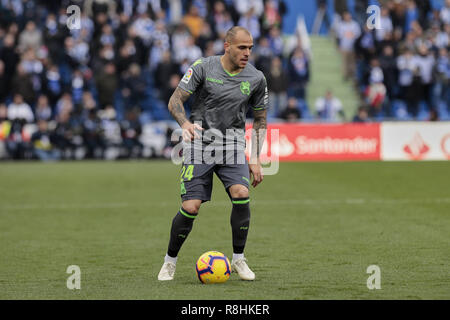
[0,0,309,160]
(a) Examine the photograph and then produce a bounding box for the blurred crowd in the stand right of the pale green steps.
[334,0,450,120]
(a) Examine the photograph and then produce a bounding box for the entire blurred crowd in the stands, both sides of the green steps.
[0,0,450,160]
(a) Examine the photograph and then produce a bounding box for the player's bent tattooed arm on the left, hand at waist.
[168,87,203,141]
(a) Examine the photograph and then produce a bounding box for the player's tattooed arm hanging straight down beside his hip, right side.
[249,110,267,187]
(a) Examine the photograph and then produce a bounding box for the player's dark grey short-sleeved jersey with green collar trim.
[178,56,268,148]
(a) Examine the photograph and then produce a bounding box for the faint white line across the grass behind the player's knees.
[0,198,450,213]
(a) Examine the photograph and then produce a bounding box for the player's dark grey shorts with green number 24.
[180,148,250,202]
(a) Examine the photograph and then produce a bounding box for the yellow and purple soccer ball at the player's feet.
[195,251,231,283]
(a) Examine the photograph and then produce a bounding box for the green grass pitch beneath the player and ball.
[0,161,450,300]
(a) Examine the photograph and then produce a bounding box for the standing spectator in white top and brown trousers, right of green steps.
[337,12,361,80]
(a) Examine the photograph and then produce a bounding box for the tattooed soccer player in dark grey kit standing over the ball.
[158,26,268,280]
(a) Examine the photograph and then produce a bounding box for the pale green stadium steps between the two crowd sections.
[307,35,359,121]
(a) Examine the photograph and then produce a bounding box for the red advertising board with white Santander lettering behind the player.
[246,123,381,161]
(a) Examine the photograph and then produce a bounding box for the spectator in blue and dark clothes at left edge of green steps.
[288,47,309,99]
